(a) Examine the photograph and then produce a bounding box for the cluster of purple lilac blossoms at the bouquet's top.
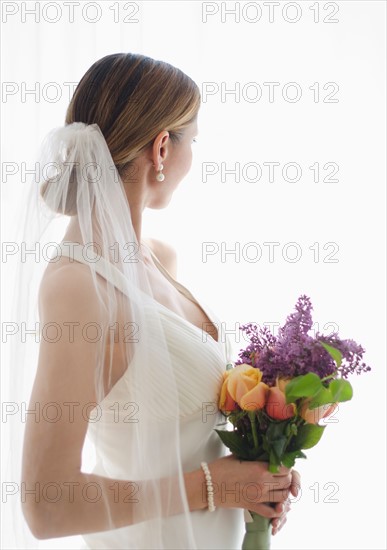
[236,295,371,386]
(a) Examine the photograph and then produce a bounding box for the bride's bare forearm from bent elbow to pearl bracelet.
[23,470,206,539]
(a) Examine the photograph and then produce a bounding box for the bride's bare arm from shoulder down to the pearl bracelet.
[21,265,206,539]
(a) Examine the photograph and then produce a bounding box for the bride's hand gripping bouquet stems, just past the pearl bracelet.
[208,455,297,519]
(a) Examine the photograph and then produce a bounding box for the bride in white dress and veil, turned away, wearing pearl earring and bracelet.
[15,54,299,548]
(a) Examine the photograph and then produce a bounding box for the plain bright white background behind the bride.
[2,1,386,550]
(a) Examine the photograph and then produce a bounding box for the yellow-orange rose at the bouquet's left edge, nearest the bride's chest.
[219,364,269,412]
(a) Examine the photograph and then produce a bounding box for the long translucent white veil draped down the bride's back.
[2,122,200,549]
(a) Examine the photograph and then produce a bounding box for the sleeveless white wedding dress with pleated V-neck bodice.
[57,247,244,550]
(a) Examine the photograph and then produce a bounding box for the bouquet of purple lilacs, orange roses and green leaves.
[216,296,370,550]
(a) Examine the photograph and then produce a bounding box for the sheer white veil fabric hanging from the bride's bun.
[3,122,236,549]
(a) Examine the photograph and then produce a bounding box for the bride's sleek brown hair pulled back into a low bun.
[41,53,201,215]
